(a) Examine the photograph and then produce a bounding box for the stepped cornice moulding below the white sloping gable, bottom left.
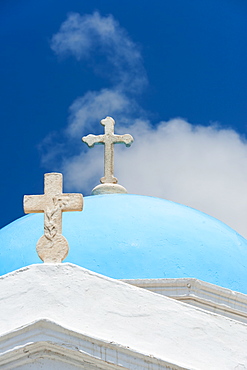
[0,320,181,370]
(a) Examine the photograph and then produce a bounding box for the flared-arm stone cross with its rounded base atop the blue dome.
[82,117,134,195]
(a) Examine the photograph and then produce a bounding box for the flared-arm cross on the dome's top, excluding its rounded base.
[82,117,134,184]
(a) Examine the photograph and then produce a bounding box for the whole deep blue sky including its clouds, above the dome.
[0,0,247,237]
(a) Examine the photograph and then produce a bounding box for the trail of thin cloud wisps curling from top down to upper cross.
[40,12,147,170]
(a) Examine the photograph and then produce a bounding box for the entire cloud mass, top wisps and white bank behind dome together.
[43,12,247,237]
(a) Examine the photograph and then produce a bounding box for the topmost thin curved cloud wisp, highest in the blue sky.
[51,12,147,92]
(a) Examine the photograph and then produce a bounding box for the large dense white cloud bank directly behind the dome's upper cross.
[63,119,247,237]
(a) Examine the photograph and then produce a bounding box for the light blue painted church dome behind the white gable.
[0,194,247,293]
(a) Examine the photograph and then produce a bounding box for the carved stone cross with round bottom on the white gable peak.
[23,173,83,263]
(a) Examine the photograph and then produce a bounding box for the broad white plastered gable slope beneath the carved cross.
[0,263,247,370]
